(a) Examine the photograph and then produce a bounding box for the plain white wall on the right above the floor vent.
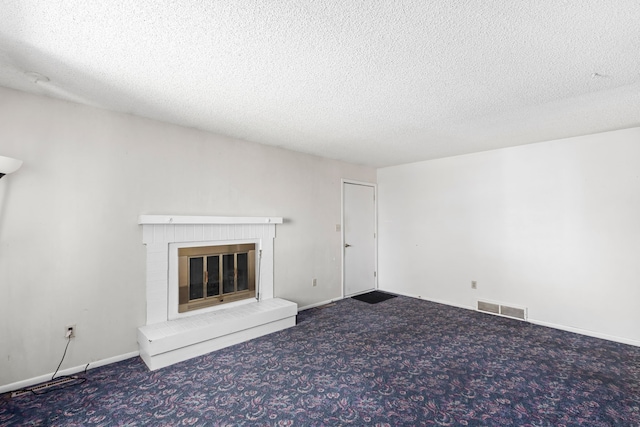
[378,128,640,345]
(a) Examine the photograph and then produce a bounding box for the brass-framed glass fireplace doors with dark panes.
[178,244,256,313]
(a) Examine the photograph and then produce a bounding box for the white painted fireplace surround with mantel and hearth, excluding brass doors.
[138,215,298,370]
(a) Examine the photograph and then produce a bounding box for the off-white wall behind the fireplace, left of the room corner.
[0,88,375,386]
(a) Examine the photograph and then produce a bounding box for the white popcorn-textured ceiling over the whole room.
[0,0,640,166]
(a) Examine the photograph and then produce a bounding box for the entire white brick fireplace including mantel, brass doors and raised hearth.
[138,215,298,370]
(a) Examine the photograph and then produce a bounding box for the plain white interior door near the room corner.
[342,182,376,296]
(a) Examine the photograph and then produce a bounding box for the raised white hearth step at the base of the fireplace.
[138,298,298,371]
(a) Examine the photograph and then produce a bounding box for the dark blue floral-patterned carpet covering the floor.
[0,297,640,427]
